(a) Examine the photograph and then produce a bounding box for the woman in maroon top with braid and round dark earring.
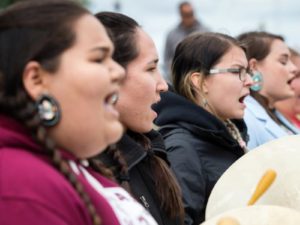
[0,0,156,225]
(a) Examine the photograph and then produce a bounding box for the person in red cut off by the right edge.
[275,48,300,128]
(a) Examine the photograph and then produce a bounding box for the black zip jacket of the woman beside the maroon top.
[101,130,180,225]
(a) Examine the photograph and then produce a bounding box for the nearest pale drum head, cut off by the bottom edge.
[201,205,300,225]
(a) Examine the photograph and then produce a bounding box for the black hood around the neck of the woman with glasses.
[154,91,248,152]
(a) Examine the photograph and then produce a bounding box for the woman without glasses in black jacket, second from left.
[96,12,183,225]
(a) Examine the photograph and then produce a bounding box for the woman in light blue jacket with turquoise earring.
[238,31,299,149]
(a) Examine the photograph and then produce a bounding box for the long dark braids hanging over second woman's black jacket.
[95,130,184,221]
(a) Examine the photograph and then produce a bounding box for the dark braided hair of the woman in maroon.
[0,0,108,225]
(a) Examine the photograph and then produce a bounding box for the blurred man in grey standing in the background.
[164,1,208,81]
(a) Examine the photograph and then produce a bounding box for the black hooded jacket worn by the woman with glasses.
[155,91,247,225]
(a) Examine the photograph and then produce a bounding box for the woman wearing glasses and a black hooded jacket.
[156,33,253,225]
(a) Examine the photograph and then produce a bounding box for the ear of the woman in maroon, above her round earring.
[22,61,45,100]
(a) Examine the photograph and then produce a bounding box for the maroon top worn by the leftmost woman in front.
[0,115,155,225]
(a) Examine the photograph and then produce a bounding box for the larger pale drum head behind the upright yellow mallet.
[206,135,300,219]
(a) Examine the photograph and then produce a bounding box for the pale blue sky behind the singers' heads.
[89,0,300,69]
